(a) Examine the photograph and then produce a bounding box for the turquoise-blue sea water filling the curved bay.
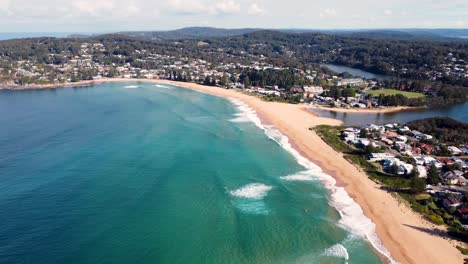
[0,83,380,263]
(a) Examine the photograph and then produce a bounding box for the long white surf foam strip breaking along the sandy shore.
[230,99,397,263]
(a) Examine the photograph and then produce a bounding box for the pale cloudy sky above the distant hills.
[0,0,468,32]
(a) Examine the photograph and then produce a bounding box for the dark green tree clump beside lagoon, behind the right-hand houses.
[408,117,468,145]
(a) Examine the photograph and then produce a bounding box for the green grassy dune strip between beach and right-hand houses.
[315,126,444,225]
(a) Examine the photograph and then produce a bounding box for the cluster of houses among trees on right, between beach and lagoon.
[318,118,468,243]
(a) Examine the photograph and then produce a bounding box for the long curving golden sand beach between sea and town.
[3,79,463,263]
